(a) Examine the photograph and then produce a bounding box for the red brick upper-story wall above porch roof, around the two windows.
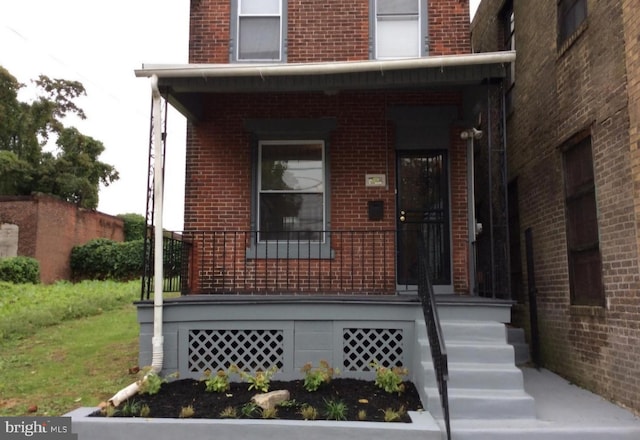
[189,0,471,63]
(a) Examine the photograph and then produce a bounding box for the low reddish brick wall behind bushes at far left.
[0,194,124,283]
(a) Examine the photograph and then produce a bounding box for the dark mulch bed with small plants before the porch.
[94,378,423,423]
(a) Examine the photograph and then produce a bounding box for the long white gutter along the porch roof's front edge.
[135,51,516,78]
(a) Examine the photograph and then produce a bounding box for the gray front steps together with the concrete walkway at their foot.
[414,312,640,440]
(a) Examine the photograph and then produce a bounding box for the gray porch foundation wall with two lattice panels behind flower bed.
[137,295,422,380]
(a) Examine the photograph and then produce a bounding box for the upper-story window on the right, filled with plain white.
[370,0,427,59]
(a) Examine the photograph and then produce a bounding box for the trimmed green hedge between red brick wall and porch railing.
[70,238,144,281]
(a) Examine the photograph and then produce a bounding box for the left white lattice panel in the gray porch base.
[187,329,284,373]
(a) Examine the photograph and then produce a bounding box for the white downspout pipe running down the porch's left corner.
[109,75,164,407]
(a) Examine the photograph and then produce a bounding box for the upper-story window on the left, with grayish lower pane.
[231,0,286,62]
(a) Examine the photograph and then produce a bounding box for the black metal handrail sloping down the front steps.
[418,227,451,440]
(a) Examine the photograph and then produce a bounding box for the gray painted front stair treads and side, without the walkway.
[417,320,535,420]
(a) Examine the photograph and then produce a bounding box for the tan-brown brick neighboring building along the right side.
[472,0,640,411]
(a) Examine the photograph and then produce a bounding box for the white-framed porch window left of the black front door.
[257,140,326,243]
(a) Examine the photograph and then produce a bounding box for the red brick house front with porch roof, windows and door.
[136,0,514,294]
